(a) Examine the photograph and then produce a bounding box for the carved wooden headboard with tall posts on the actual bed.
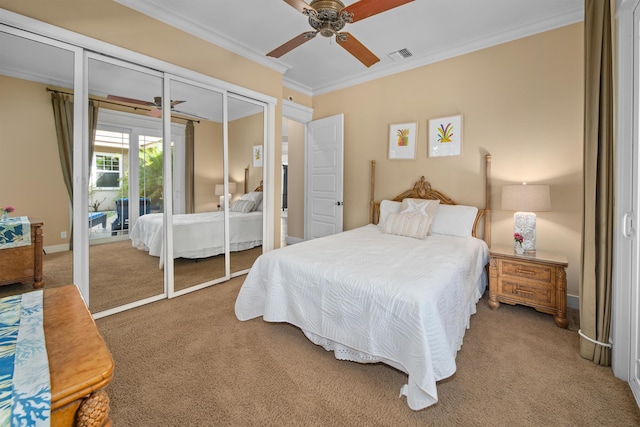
[369,154,491,247]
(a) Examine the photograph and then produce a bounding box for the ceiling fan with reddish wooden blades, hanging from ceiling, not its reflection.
[267,0,414,67]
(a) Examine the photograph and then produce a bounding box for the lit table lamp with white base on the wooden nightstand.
[502,182,551,254]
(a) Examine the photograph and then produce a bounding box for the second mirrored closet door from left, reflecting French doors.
[87,57,165,313]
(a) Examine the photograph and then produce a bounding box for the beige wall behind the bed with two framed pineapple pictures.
[313,23,583,295]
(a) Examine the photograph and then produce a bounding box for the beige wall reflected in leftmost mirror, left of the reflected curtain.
[0,76,71,246]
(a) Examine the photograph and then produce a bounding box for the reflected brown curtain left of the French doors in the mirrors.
[51,92,100,250]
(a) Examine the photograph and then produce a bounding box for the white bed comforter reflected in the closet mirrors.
[129,211,262,267]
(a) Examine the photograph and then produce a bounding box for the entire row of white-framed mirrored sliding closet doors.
[0,18,275,318]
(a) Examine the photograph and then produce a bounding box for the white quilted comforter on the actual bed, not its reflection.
[235,225,489,410]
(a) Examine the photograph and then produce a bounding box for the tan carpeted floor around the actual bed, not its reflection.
[96,277,640,426]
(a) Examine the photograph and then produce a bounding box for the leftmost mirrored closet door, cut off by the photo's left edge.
[0,27,75,296]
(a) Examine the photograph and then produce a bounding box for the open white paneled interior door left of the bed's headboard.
[305,114,344,240]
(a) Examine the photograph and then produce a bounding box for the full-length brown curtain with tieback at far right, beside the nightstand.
[579,0,614,366]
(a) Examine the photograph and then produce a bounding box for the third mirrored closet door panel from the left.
[170,79,227,295]
